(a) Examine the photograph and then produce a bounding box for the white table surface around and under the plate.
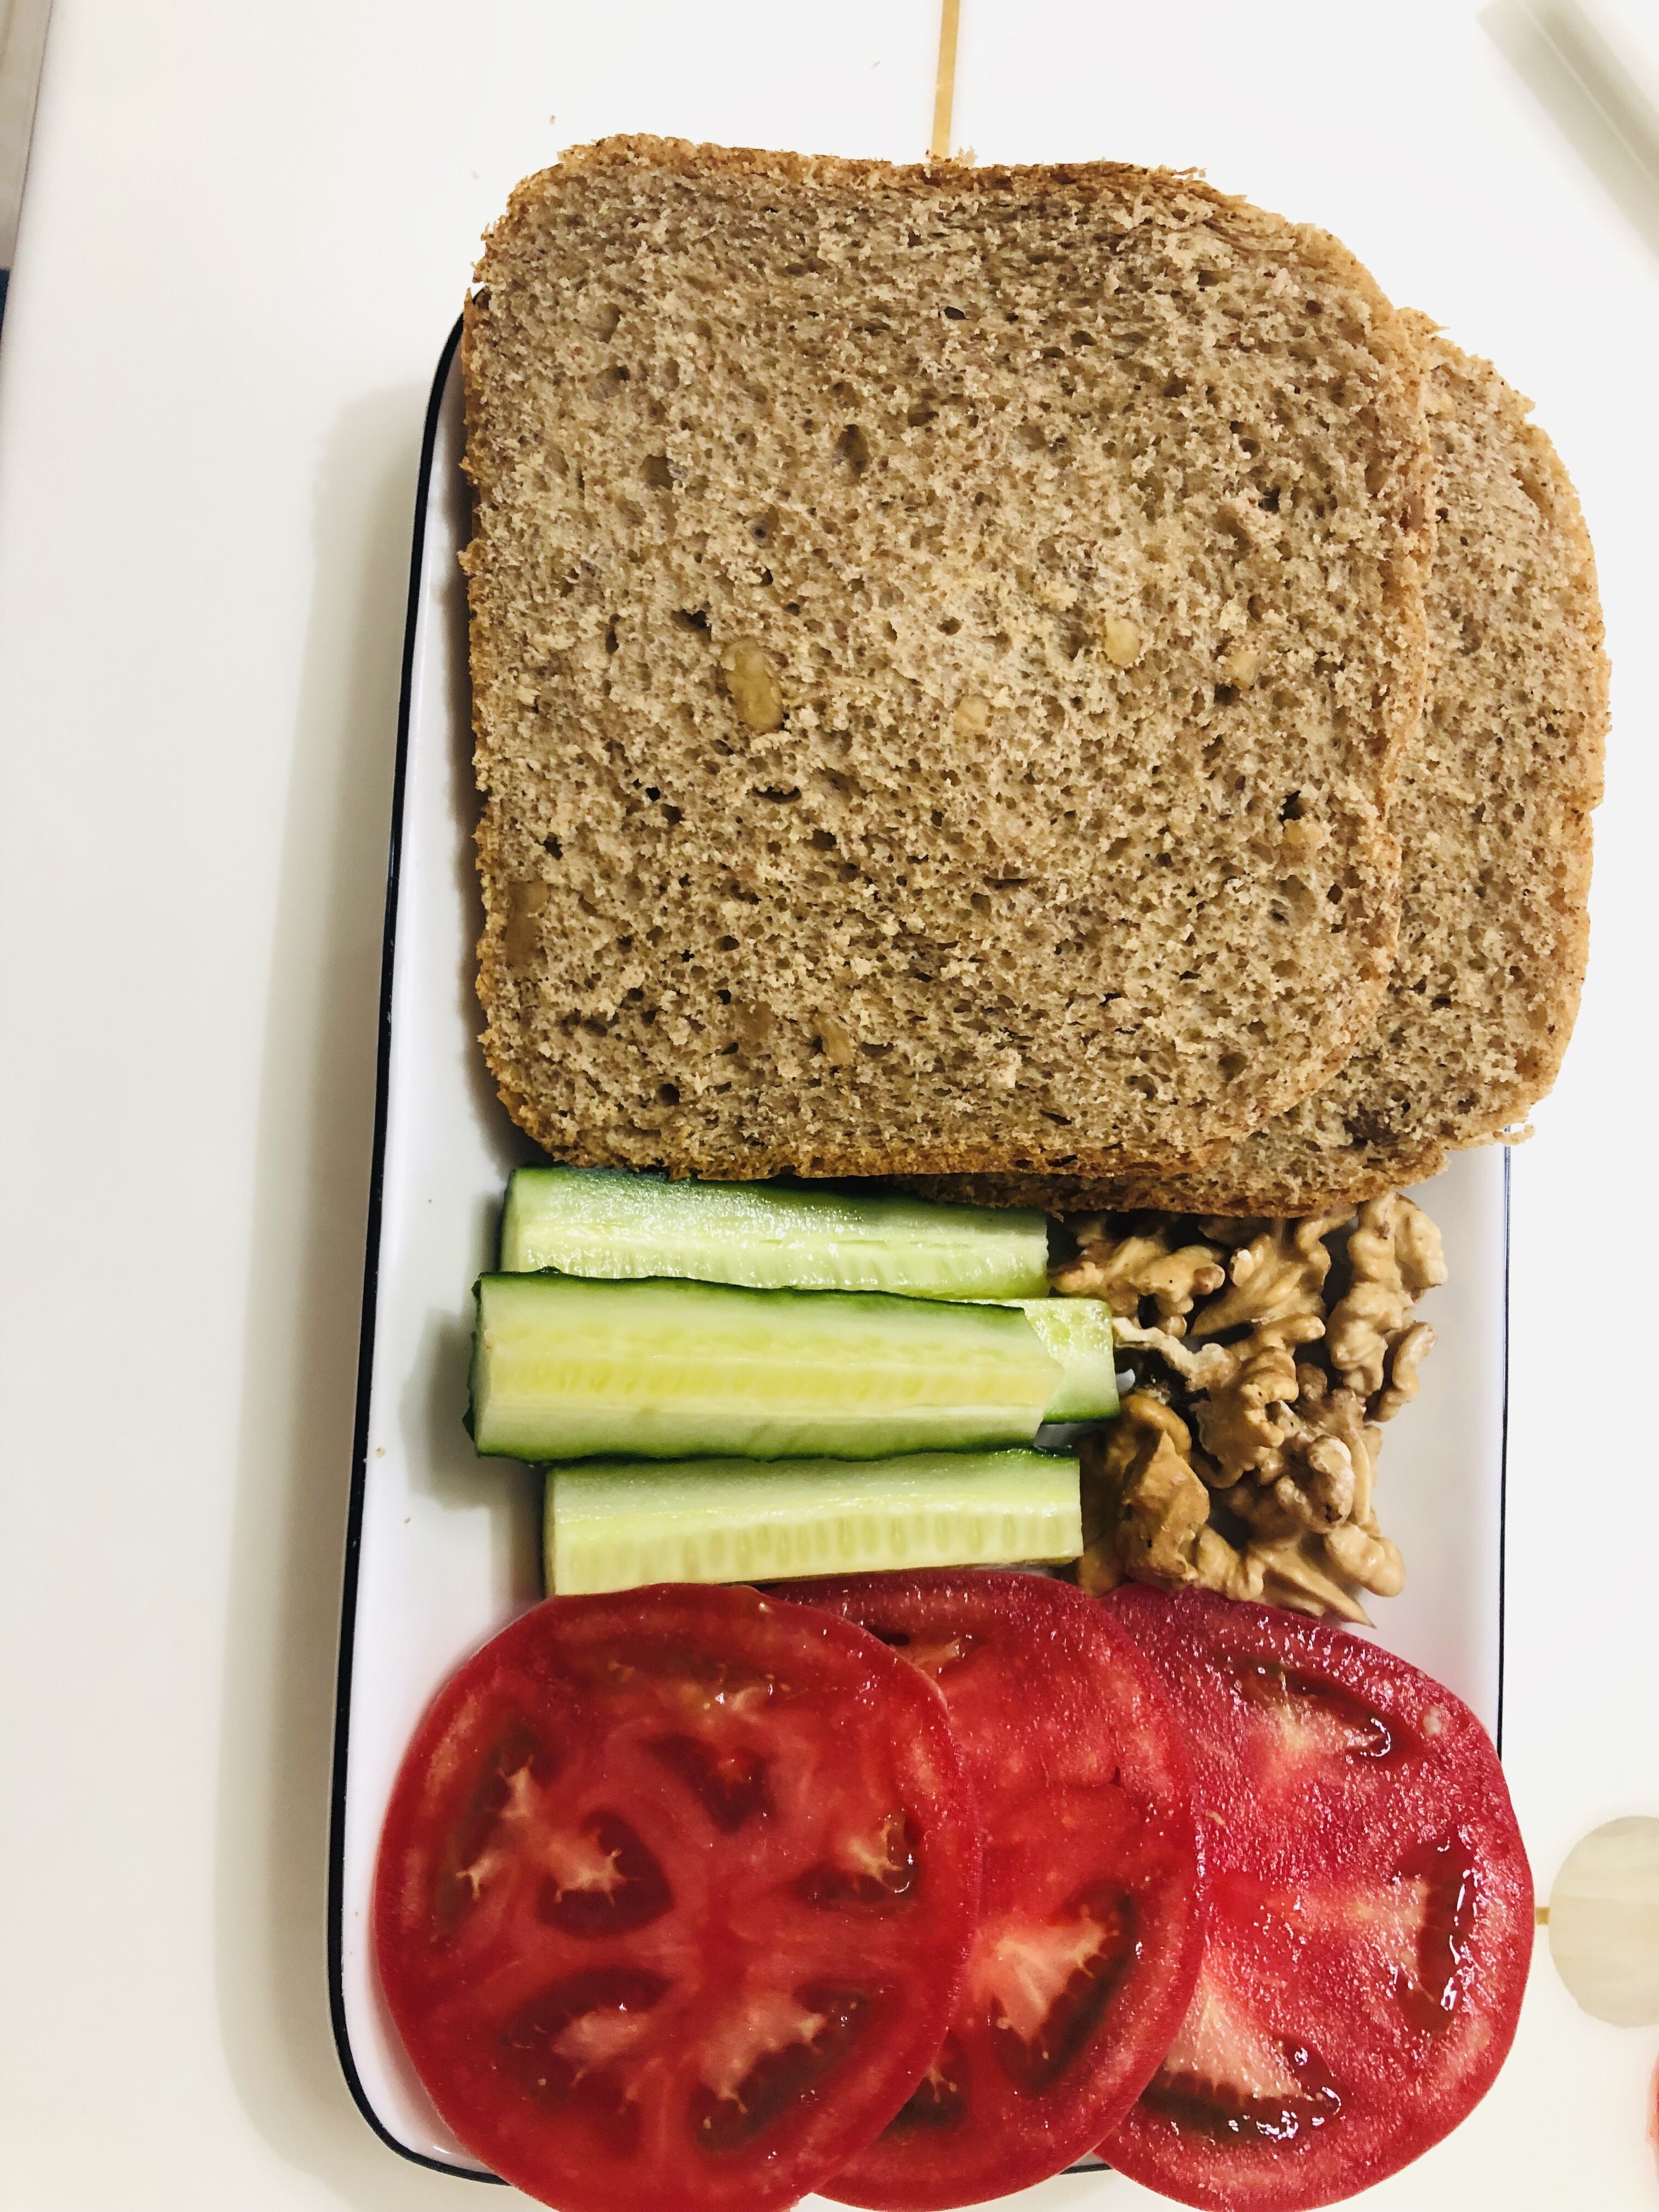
[0,0,1659,2212]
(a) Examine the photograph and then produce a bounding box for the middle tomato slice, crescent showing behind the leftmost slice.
[787,1573,1201,2212]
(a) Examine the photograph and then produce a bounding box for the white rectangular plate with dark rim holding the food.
[330,323,1509,2190]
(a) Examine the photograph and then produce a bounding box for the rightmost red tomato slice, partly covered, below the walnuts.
[1099,1584,1533,2212]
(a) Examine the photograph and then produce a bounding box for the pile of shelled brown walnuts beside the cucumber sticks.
[1053,1192,1447,1621]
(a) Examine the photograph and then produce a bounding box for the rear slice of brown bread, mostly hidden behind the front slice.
[936,317,1608,1215]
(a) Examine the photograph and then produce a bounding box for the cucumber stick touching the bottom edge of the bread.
[502,1168,1048,1301]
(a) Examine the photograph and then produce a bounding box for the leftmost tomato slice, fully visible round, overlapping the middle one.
[374,1586,980,2212]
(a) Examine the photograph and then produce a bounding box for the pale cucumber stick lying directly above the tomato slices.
[542,1451,1082,1595]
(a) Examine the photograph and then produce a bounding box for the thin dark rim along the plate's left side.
[328,319,502,2188]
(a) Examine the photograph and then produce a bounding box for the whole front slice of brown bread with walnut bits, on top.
[465,139,1431,1177]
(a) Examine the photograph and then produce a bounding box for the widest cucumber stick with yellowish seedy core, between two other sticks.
[471,1274,1064,1460]
